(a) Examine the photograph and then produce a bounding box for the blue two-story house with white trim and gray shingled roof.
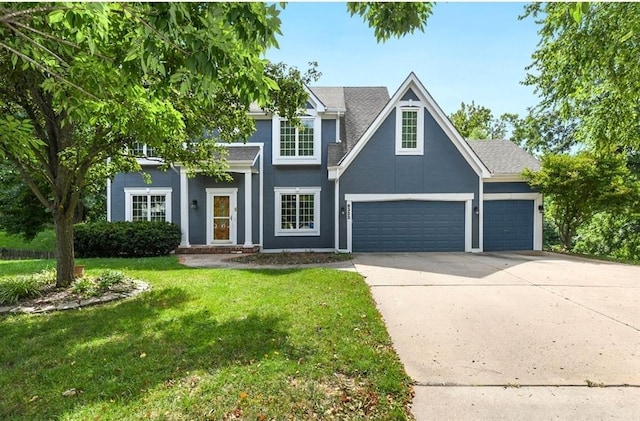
[107,73,543,252]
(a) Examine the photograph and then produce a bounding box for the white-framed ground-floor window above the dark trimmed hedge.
[124,187,172,222]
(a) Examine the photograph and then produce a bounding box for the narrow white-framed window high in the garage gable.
[396,103,424,155]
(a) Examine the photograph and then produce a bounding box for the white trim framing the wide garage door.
[344,193,474,253]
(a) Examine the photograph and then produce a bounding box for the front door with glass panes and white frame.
[207,189,238,244]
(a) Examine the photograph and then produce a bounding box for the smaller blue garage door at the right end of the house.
[484,200,534,251]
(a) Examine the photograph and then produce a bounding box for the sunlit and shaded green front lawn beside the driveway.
[0,257,411,420]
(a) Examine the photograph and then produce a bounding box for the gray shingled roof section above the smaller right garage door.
[468,139,540,175]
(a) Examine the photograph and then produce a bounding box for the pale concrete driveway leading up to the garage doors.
[354,253,640,420]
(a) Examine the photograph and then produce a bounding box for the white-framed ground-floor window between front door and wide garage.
[274,187,321,236]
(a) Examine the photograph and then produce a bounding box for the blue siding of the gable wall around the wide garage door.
[340,110,479,249]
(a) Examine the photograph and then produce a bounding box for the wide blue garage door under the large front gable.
[351,201,464,252]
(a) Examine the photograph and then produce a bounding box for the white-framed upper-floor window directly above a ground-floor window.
[272,116,322,165]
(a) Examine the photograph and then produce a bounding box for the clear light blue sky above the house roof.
[267,3,538,117]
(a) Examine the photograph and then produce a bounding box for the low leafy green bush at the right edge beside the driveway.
[573,212,640,260]
